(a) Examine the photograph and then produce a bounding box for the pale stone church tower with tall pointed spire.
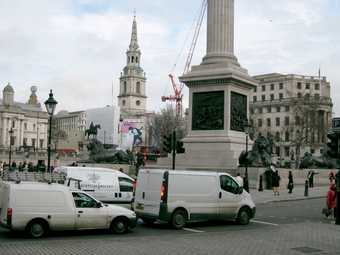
[118,16,147,118]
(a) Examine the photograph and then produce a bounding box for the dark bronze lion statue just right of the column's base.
[239,135,273,167]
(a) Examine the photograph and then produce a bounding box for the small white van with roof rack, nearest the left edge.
[0,182,136,238]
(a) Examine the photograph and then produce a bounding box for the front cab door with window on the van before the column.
[219,175,242,219]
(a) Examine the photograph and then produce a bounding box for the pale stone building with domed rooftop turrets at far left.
[0,83,48,160]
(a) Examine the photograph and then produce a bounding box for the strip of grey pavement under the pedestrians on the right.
[250,185,328,204]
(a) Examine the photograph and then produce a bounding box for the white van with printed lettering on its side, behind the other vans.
[54,166,134,204]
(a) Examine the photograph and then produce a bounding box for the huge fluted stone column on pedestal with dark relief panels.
[177,0,257,170]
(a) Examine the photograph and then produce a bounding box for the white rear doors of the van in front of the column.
[135,170,165,217]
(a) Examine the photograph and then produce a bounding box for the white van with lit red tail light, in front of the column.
[134,169,255,229]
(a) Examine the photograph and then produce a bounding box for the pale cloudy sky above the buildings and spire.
[0,0,340,116]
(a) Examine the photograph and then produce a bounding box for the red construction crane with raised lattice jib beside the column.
[162,0,208,118]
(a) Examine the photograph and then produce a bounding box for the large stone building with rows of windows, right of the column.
[250,73,333,163]
